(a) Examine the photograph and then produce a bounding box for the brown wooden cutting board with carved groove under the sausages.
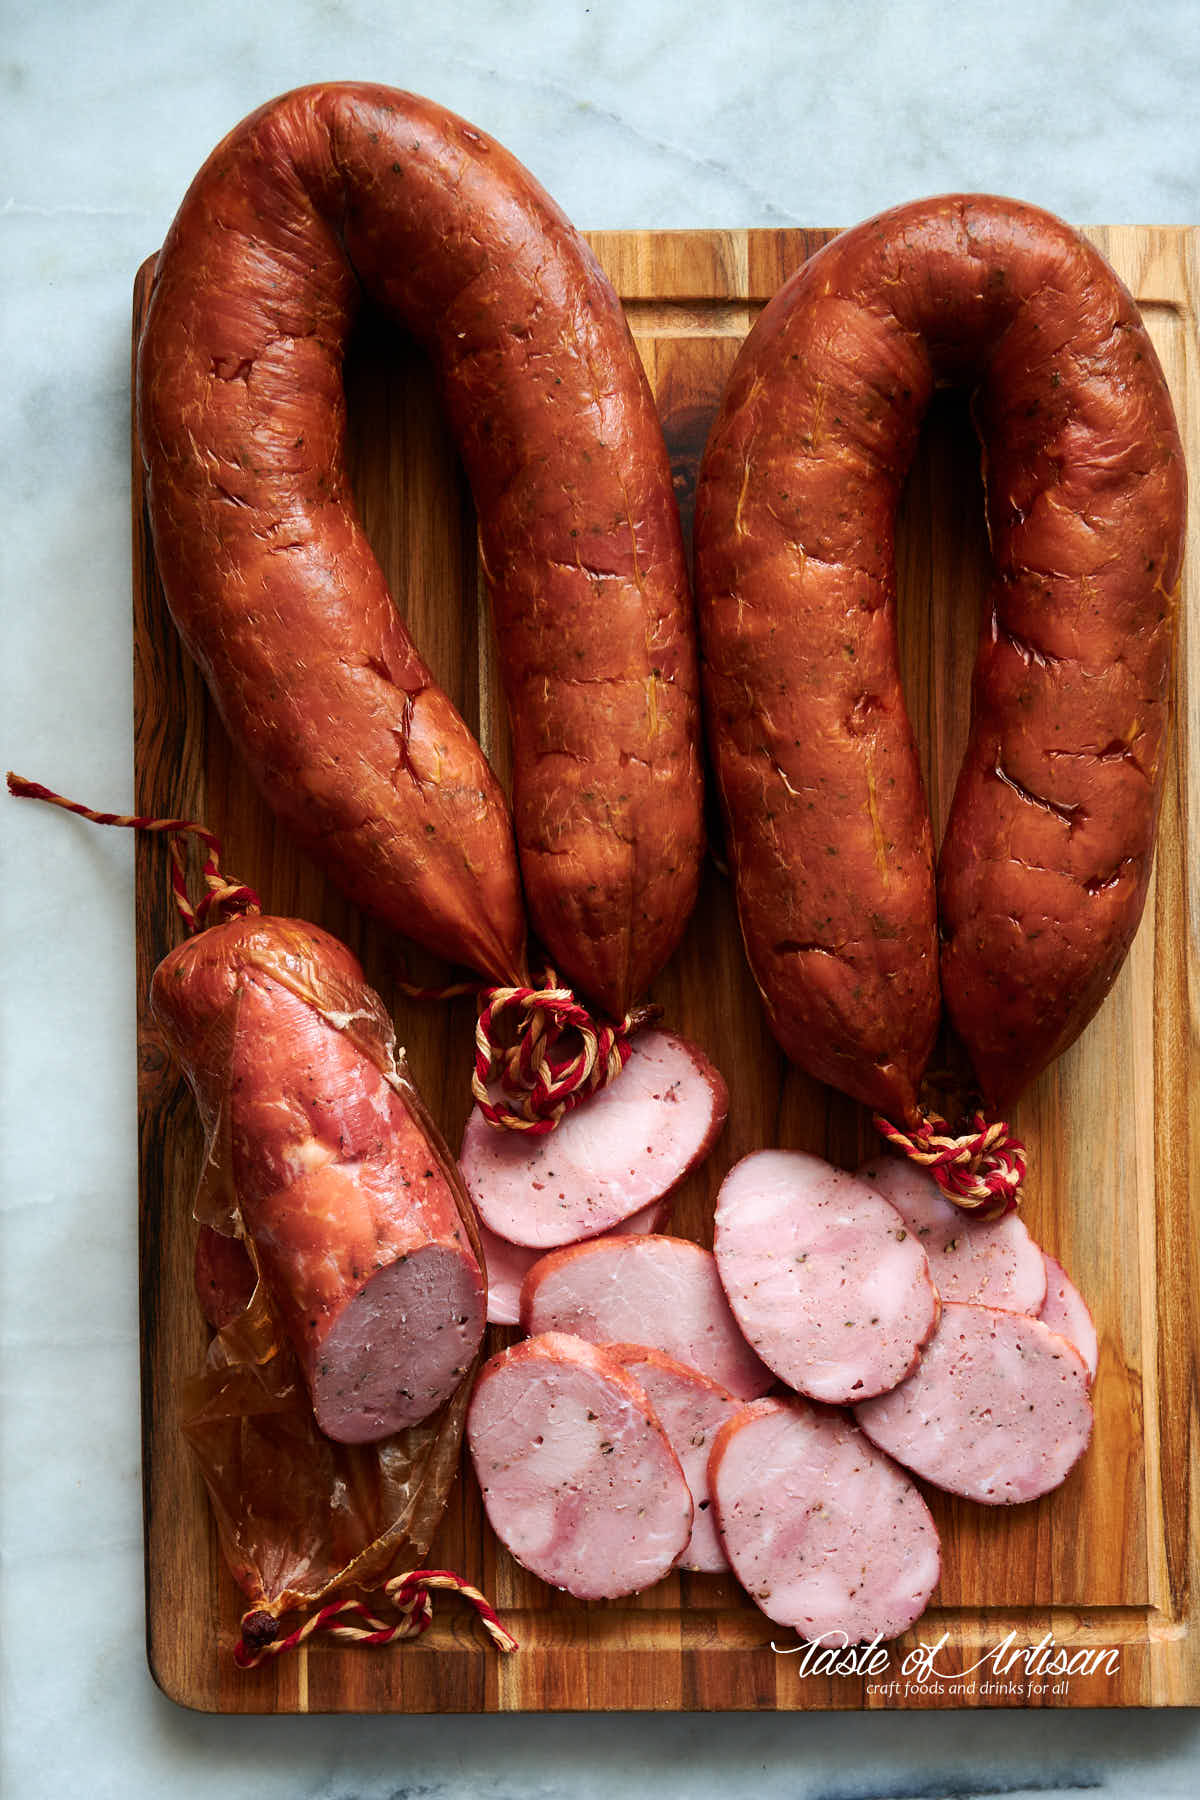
[133,227,1200,1712]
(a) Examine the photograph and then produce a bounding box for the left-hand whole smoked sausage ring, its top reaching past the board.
[139,85,702,1019]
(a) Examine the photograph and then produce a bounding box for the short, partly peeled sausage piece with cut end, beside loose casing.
[151,918,486,1444]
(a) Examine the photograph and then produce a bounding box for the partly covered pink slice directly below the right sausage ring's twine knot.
[858,1156,1045,1316]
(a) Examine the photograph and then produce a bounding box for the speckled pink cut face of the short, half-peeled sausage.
[311,1244,486,1444]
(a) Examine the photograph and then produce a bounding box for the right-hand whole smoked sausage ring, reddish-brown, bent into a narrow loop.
[696,194,1186,1123]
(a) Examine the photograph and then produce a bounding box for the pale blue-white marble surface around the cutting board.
[0,0,1200,1800]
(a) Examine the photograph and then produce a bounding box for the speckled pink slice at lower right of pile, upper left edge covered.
[855,1301,1092,1507]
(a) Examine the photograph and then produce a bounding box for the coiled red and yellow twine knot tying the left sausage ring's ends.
[471,968,658,1138]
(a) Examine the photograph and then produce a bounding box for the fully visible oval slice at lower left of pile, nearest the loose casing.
[466,1332,693,1600]
